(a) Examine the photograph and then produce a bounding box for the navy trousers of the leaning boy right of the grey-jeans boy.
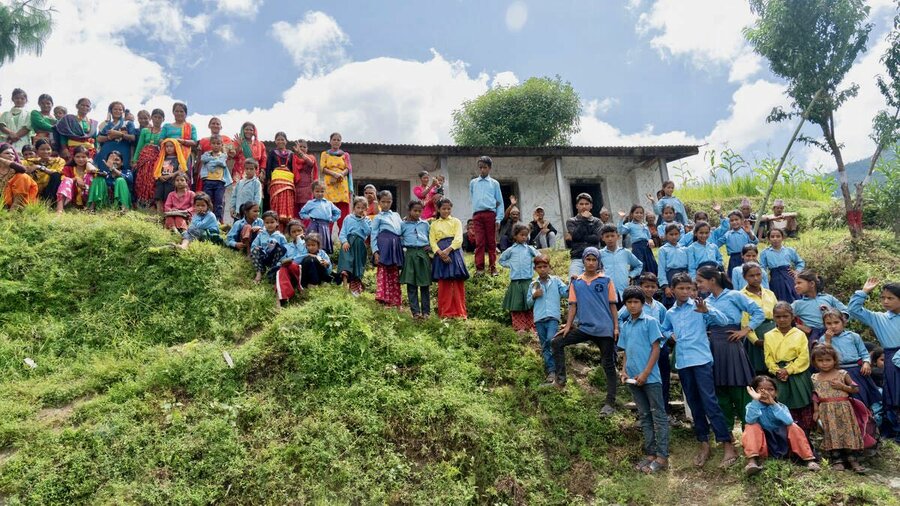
[678,362,732,443]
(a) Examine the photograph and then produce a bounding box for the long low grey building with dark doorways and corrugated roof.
[310,142,699,231]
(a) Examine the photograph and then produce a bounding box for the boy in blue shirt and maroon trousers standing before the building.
[469,156,503,276]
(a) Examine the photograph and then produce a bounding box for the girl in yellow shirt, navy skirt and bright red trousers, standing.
[429,197,469,318]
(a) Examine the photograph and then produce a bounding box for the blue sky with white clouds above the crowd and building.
[0,0,896,175]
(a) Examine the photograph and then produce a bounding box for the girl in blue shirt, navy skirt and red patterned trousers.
[370,190,404,307]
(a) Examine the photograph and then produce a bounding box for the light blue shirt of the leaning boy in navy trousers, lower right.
[662,299,727,369]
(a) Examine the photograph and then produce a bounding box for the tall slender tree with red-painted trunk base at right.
[744,0,872,239]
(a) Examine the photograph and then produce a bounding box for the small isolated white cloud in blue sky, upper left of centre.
[272,11,350,75]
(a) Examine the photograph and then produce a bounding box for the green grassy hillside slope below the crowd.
[0,209,900,504]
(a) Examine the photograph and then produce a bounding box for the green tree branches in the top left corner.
[0,0,53,66]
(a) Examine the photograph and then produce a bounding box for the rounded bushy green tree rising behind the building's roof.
[450,76,581,146]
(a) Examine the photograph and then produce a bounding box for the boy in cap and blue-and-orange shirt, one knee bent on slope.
[553,247,619,416]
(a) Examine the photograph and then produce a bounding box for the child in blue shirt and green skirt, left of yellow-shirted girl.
[400,200,431,319]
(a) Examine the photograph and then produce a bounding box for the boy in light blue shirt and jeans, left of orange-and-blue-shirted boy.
[526,255,569,385]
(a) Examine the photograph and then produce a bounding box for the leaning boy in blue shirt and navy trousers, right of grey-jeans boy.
[662,274,737,467]
